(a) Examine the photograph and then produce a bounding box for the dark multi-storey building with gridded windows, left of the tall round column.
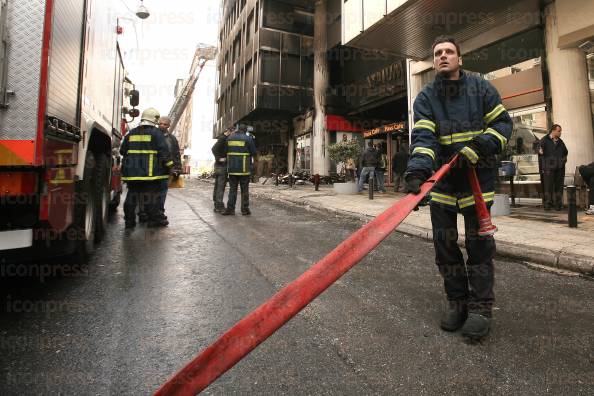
[214,0,314,170]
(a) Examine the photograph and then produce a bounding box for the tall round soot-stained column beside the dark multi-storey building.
[311,0,330,175]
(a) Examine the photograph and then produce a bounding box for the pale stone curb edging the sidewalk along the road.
[253,187,594,276]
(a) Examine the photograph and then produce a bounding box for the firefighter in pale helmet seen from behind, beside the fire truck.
[120,108,173,229]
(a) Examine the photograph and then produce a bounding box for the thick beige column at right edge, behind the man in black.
[545,3,594,176]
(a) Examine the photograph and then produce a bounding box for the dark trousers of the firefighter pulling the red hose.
[431,205,495,316]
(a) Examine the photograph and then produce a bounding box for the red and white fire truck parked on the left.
[0,0,139,262]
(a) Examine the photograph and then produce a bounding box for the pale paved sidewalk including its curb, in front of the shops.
[236,179,594,275]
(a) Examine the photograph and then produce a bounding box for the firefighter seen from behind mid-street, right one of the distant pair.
[223,124,256,216]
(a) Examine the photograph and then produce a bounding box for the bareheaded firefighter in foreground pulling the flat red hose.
[404,36,512,341]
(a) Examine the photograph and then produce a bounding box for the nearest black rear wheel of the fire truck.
[73,151,97,261]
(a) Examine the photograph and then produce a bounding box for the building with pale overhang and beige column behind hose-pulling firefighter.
[342,0,594,189]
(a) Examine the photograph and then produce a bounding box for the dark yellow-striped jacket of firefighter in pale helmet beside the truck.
[120,126,173,181]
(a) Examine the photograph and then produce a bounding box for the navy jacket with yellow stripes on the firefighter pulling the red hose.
[406,70,513,210]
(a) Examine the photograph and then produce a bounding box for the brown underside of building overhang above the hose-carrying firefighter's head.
[343,0,541,60]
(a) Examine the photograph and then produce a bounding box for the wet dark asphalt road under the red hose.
[0,182,594,395]
